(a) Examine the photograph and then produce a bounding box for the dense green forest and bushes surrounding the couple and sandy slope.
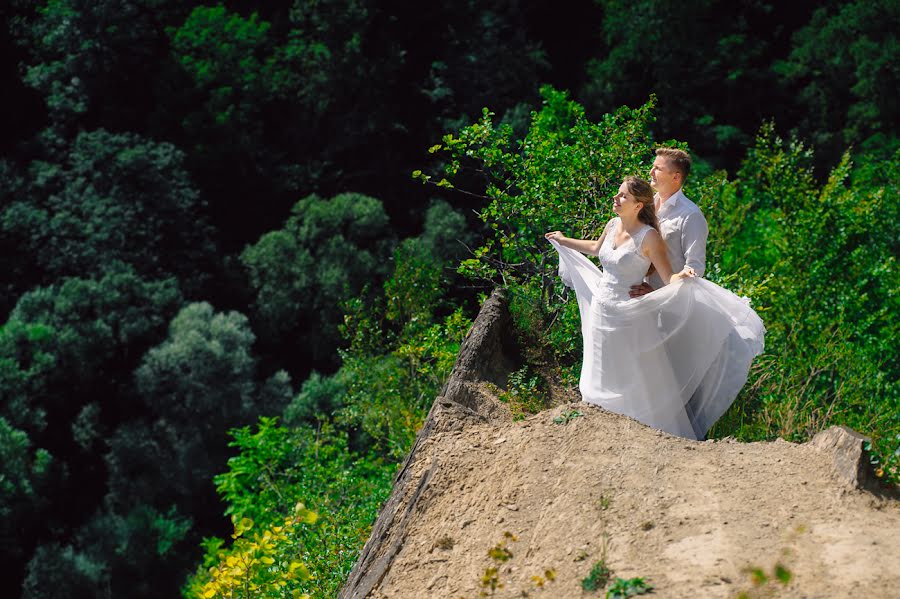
[0,0,900,598]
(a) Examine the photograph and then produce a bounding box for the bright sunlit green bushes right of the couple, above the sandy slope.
[714,125,900,477]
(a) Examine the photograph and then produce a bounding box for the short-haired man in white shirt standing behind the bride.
[631,148,709,297]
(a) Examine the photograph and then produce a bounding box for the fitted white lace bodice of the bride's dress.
[597,218,653,301]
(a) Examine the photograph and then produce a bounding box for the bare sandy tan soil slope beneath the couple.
[372,404,900,597]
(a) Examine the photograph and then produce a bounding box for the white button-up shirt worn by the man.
[647,189,709,289]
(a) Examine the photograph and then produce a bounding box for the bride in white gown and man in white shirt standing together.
[546,148,765,439]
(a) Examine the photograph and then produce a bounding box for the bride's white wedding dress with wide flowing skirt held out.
[550,218,765,439]
